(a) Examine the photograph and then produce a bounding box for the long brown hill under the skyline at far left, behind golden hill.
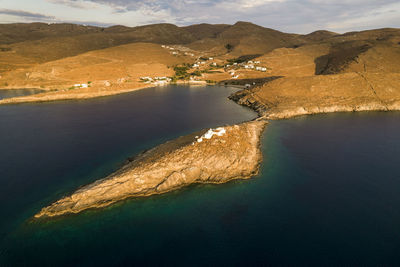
[0,24,195,68]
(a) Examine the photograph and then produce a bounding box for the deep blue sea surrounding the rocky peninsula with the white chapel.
[0,87,400,266]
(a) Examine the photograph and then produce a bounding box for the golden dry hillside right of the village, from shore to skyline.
[233,30,400,118]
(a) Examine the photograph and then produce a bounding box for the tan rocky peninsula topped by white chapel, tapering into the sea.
[35,119,267,218]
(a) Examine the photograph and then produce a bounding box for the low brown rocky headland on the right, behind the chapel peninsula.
[231,73,400,119]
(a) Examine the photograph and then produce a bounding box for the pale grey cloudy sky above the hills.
[0,0,400,33]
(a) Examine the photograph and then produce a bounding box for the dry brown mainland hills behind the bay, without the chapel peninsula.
[0,22,400,108]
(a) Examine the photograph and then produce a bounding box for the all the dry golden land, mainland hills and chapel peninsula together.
[0,22,400,217]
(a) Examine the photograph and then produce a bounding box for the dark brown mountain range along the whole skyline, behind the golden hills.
[0,22,400,74]
